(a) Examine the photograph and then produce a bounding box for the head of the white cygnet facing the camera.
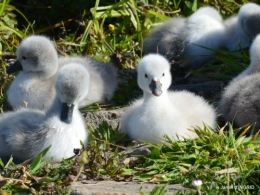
[137,54,172,96]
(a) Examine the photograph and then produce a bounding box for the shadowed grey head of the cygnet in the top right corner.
[238,3,260,40]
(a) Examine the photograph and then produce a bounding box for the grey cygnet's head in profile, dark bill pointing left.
[7,35,58,77]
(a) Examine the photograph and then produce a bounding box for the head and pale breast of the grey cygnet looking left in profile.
[7,35,58,110]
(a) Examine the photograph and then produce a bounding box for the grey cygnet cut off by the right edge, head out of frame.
[219,35,260,129]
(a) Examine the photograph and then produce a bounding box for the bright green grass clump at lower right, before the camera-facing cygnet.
[133,125,260,194]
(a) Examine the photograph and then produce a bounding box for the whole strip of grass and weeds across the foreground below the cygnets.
[0,122,260,195]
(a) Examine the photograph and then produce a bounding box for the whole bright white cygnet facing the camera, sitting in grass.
[121,54,216,142]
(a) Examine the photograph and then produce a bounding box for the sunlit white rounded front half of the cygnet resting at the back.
[180,6,225,68]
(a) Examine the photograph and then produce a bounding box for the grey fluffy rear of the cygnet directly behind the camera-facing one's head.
[143,17,186,61]
